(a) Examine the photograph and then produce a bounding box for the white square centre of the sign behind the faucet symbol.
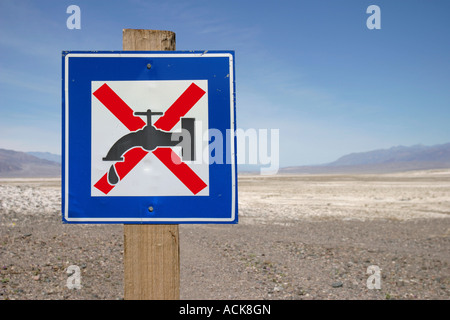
[91,80,209,197]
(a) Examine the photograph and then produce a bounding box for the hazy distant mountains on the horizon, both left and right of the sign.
[0,143,450,178]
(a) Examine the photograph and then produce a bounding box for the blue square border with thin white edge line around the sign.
[62,51,238,224]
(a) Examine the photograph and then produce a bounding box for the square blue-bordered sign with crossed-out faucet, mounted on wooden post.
[62,51,238,224]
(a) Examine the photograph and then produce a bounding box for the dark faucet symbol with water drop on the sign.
[103,109,195,185]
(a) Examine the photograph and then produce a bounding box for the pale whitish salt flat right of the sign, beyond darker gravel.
[239,170,450,222]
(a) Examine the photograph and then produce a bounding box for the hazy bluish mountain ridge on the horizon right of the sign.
[279,143,450,174]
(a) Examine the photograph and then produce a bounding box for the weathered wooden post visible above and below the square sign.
[123,29,180,300]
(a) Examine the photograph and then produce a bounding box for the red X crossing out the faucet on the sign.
[93,83,207,194]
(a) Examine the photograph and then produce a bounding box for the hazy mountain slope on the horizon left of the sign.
[0,149,61,178]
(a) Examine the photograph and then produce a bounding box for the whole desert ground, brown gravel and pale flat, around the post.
[0,170,450,300]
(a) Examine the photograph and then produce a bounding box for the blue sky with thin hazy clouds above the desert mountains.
[0,0,450,167]
